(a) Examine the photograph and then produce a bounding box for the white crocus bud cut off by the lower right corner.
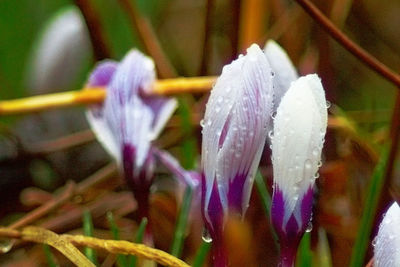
[374,202,400,267]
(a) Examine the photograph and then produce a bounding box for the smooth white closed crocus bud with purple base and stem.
[271,74,327,266]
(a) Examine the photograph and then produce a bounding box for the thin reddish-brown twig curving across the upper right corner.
[296,0,400,88]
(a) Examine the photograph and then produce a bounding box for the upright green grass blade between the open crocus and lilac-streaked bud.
[171,186,193,258]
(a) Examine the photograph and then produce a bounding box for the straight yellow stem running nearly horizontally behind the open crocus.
[0,76,216,115]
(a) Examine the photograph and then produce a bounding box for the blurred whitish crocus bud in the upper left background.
[27,7,90,94]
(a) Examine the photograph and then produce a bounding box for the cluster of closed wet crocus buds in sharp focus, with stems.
[201,42,327,266]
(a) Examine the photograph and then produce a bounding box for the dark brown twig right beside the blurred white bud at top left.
[75,0,111,61]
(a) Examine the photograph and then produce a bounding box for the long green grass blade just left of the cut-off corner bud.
[350,147,388,267]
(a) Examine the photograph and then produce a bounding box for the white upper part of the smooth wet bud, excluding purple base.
[272,74,327,224]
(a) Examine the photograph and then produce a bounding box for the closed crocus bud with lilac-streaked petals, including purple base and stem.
[201,45,273,266]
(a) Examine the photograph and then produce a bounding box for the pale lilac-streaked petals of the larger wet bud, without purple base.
[202,45,272,217]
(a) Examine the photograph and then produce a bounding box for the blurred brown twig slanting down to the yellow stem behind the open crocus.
[119,0,178,78]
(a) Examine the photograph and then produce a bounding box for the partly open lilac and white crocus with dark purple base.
[87,50,176,220]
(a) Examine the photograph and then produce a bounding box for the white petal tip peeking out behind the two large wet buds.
[264,40,298,111]
